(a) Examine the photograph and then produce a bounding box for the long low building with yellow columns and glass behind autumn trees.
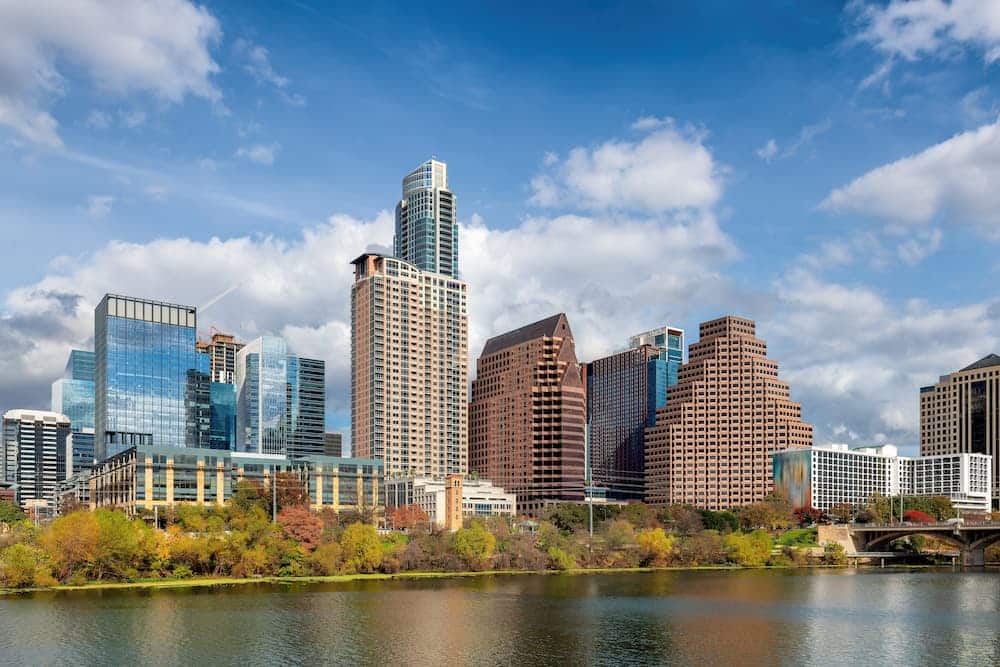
[90,446,383,514]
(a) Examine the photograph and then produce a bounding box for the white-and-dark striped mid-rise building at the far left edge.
[3,410,70,511]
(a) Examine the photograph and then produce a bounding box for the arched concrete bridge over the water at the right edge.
[818,521,1000,565]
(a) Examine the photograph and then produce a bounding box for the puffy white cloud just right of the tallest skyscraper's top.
[530,117,722,213]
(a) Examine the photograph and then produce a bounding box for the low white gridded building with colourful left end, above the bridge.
[773,445,992,512]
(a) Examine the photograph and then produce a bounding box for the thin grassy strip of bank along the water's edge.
[0,565,968,596]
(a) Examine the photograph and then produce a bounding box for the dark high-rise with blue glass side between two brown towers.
[586,327,684,500]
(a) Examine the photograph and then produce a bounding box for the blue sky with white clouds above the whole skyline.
[0,0,1000,451]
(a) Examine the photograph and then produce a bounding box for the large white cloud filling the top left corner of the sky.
[0,0,222,147]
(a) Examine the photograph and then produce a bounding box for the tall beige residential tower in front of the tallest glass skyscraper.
[351,253,469,478]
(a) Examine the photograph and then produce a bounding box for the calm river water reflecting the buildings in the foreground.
[0,570,1000,666]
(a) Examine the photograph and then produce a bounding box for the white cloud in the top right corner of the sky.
[850,0,1000,63]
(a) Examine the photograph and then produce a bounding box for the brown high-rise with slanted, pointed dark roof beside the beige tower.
[469,313,586,514]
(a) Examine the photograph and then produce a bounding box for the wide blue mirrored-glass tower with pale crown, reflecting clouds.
[94,294,210,461]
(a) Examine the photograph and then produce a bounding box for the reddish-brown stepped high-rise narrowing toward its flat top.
[646,316,812,510]
